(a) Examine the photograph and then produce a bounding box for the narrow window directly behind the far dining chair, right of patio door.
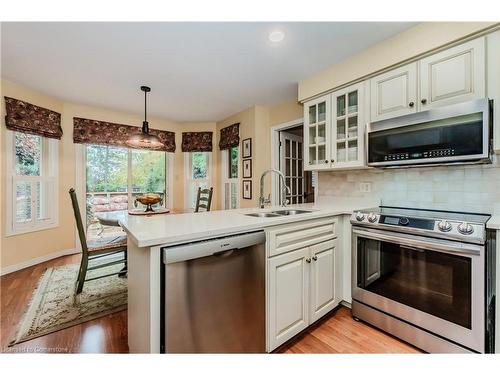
[184,152,212,209]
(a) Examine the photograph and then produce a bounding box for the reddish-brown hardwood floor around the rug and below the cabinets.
[0,255,421,353]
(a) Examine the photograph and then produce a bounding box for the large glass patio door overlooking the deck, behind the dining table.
[85,145,172,238]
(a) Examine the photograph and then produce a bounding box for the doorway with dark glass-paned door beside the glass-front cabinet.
[272,120,316,204]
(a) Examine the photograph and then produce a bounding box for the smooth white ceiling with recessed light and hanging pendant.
[1,22,415,122]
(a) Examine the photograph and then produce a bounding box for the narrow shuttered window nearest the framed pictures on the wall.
[222,146,239,210]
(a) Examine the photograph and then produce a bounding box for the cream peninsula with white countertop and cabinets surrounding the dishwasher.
[121,197,379,353]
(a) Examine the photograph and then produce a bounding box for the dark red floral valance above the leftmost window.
[4,96,62,139]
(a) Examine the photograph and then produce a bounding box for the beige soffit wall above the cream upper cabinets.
[298,22,498,101]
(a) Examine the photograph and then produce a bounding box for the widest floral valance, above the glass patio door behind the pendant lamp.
[73,117,175,152]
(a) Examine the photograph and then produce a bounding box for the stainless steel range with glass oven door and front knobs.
[352,207,494,353]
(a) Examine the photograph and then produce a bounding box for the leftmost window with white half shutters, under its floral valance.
[6,130,58,235]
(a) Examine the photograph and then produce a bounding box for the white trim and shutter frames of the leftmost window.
[5,130,59,236]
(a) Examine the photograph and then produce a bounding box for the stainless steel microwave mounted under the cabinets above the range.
[367,98,491,167]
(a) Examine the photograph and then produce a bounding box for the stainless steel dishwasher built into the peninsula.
[162,231,265,353]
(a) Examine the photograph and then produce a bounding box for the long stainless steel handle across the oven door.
[352,229,482,255]
